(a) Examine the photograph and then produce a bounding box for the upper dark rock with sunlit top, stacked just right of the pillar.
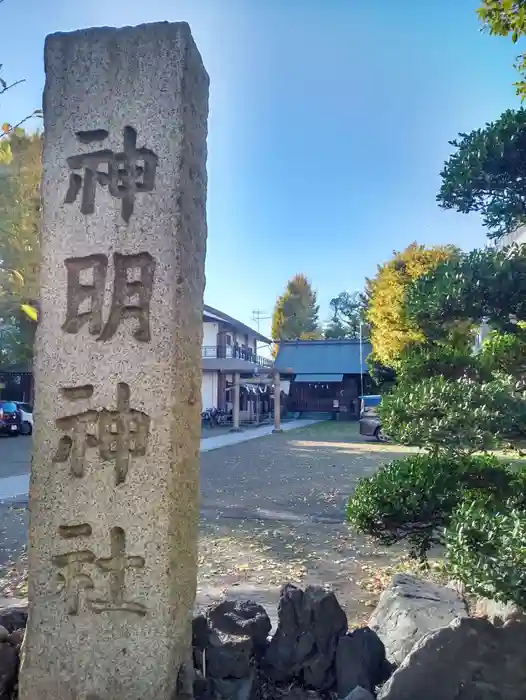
[206,600,272,646]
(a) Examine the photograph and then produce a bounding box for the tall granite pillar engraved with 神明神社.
[20,22,208,700]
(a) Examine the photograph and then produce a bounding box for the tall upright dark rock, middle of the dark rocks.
[265,584,347,690]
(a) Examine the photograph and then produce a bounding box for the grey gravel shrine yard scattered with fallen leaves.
[0,422,416,624]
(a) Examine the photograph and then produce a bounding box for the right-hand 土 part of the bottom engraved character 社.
[90,527,146,615]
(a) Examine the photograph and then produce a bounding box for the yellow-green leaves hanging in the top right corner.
[477,0,526,99]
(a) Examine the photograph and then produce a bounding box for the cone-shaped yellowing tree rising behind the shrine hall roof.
[272,274,321,350]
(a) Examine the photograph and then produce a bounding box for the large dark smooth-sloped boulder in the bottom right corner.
[378,618,526,700]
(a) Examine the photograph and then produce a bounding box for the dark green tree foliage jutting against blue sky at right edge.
[437,109,526,238]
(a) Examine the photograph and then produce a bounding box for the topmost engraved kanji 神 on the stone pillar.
[64,126,158,222]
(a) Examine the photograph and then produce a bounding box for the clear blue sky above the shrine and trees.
[0,0,519,340]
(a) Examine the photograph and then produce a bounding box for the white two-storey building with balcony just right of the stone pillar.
[201,304,273,420]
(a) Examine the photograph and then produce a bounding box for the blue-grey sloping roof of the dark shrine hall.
[274,338,372,381]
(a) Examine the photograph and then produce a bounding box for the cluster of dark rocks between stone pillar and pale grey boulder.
[193,584,391,700]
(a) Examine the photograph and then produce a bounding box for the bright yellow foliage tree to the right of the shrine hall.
[366,242,459,369]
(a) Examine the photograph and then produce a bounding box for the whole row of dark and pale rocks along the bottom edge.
[0,575,526,700]
